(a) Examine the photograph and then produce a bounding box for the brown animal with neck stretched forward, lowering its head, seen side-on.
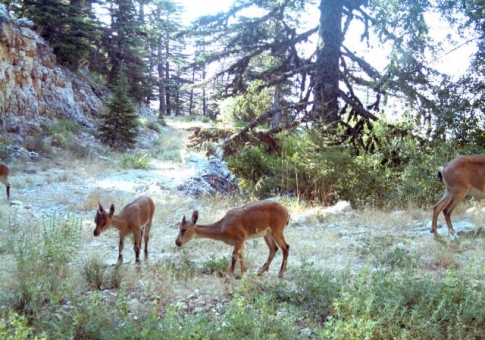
[175,201,290,277]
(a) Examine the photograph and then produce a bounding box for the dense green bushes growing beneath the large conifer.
[227,124,467,207]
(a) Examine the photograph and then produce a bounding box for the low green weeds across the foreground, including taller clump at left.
[0,231,485,339]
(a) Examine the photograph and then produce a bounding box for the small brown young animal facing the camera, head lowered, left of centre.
[94,196,155,263]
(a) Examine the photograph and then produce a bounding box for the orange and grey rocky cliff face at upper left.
[0,5,102,135]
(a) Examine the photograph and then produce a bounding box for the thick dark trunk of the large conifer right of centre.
[313,0,343,125]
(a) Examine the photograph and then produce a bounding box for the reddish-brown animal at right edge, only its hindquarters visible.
[430,155,485,237]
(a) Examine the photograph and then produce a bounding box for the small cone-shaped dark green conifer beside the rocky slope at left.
[98,68,138,151]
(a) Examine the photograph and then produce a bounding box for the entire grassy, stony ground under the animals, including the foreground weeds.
[0,119,485,339]
